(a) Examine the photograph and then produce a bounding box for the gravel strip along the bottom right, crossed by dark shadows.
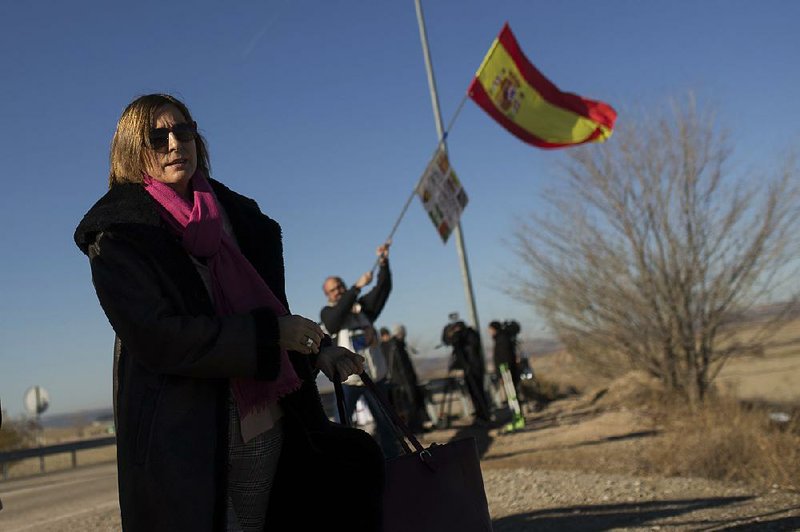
[484,468,800,532]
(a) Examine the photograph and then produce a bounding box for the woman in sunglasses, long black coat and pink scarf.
[75,94,383,532]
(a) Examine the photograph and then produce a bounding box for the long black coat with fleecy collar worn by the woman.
[75,180,383,532]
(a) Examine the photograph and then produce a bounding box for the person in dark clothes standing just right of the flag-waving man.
[384,324,427,432]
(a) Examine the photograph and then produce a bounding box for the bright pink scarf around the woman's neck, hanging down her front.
[144,170,301,423]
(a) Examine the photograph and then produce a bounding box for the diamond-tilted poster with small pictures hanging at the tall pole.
[417,149,468,243]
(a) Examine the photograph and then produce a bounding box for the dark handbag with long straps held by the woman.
[334,372,492,532]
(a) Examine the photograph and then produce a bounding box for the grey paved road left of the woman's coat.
[0,463,119,532]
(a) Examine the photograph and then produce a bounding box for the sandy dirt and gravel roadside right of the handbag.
[424,372,800,532]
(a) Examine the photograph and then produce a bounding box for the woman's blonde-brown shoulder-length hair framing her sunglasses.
[108,94,210,188]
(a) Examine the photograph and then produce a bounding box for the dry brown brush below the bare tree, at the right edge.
[641,397,800,489]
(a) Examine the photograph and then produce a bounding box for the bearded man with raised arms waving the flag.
[320,242,401,458]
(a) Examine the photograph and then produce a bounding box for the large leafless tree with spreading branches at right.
[512,98,800,401]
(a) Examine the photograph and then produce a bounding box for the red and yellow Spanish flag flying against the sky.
[467,23,617,148]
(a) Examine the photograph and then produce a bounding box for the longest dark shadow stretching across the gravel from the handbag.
[492,497,752,532]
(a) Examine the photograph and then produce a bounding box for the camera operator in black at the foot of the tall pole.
[442,321,491,425]
